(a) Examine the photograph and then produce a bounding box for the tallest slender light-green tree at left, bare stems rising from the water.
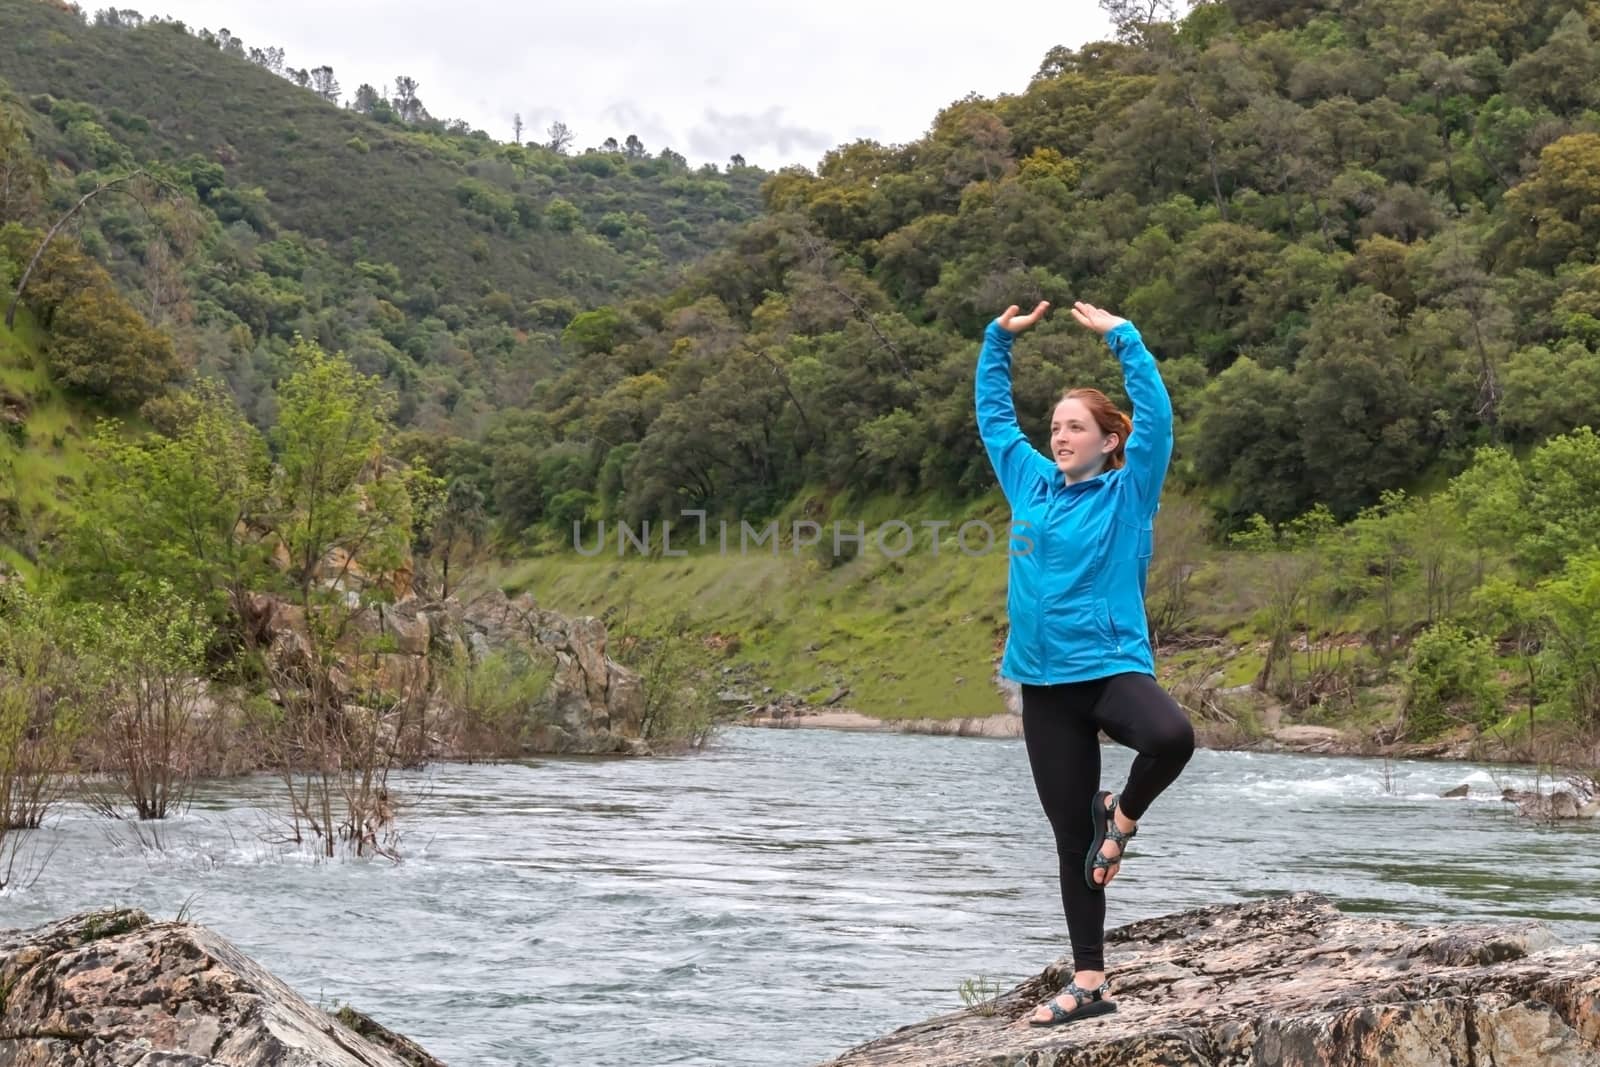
[259,341,430,856]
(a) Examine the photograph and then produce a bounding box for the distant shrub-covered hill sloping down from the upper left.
[0,0,766,437]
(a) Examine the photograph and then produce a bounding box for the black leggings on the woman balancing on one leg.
[1022,673,1195,971]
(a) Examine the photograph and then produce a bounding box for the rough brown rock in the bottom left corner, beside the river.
[0,910,443,1067]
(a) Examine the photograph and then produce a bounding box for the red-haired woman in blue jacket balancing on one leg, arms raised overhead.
[976,304,1194,1025]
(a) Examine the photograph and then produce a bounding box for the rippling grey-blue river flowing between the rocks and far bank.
[0,729,1600,1067]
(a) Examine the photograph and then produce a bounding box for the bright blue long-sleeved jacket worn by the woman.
[976,322,1173,685]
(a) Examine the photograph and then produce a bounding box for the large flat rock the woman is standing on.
[832,894,1600,1067]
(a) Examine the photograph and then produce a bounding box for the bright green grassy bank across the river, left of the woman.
[498,498,1006,718]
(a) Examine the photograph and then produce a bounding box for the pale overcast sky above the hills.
[147,0,1110,170]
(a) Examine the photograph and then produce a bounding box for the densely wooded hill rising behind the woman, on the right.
[451,0,1600,530]
